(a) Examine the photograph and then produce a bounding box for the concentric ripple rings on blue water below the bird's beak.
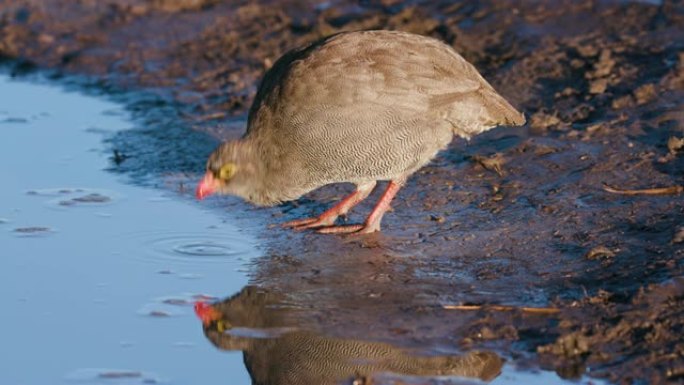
[122,229,251,263]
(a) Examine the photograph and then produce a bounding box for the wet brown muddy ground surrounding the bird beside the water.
[0,0,684,384]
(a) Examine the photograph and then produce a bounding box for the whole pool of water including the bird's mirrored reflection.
[0,73,608,385]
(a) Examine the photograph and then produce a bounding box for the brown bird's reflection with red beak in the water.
[195,287,502,385]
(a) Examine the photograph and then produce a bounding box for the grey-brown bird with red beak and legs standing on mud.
[196,30,525,234]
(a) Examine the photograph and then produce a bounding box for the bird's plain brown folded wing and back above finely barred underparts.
[249,31,524,141]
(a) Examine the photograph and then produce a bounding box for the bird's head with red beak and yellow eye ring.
[195,140,257,200]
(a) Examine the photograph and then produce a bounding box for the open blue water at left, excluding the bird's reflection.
[0,77,259,385]
